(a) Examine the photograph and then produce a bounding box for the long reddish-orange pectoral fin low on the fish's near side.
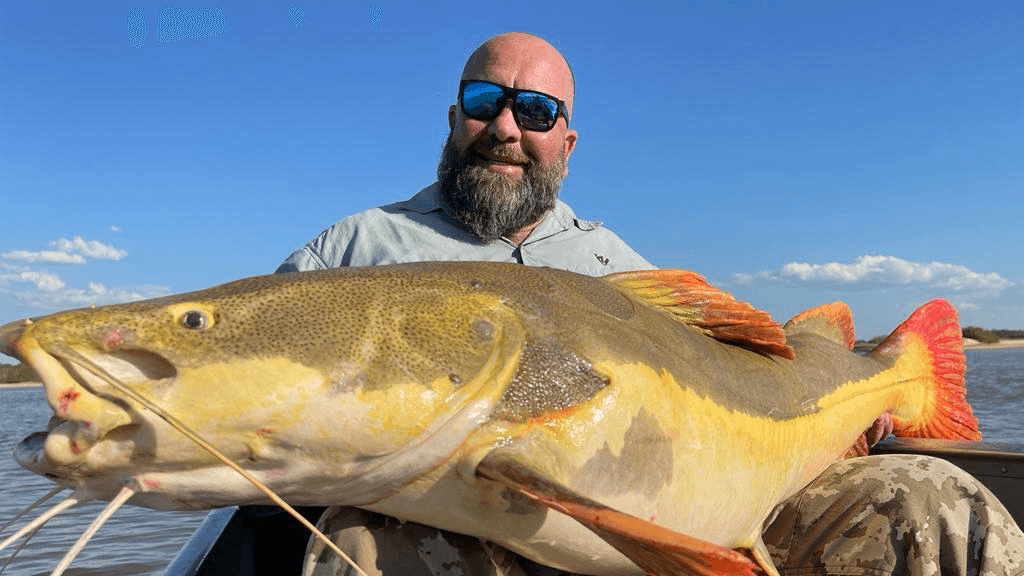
[476,452,760,576]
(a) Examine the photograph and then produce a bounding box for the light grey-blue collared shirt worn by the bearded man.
[276,182,654,276]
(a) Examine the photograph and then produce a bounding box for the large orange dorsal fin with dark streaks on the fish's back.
[604,270,794,360]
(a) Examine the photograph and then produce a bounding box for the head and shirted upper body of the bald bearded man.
[278,33,653,276]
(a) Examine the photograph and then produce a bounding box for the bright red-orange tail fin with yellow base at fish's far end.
[869,300,981,440]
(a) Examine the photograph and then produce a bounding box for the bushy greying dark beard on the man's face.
[437,132,565,242]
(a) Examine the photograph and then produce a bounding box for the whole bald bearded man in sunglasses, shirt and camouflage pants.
[279,33,1024,576]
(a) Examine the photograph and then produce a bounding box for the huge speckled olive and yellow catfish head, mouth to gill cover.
[0,266,523,509]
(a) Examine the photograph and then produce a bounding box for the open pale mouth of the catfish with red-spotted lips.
[0,320,177,471]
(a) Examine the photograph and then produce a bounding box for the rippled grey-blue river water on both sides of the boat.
[0,348,1024,576]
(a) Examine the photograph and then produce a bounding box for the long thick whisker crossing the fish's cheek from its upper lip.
[51,345,369,576]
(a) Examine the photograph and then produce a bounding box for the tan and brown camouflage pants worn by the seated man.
[303,455,1024,576]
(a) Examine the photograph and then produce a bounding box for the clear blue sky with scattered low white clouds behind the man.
[0,0,1024,337]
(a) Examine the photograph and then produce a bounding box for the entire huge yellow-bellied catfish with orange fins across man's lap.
[0,262,979,575]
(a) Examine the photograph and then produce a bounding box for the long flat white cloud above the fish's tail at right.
[733,255,1014,294]
